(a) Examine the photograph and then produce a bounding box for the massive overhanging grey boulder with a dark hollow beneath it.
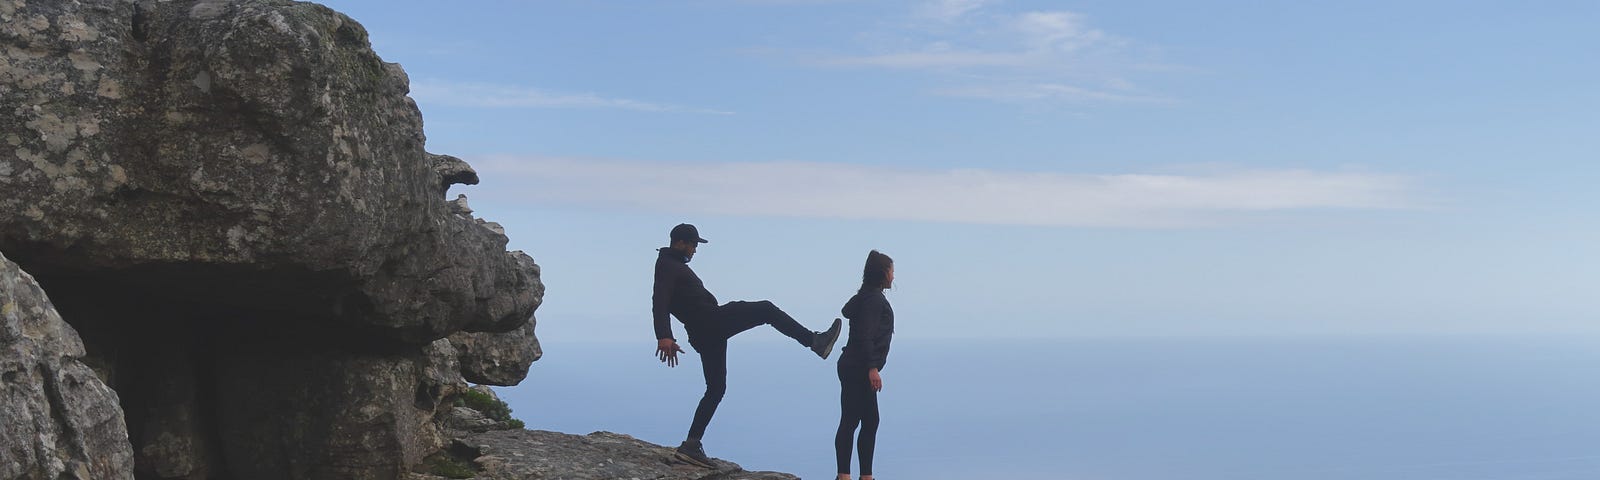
[0,0,544,478]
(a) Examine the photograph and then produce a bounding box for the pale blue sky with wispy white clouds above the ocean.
[326,0,1600,339]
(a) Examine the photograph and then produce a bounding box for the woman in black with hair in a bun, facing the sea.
[834,250,894,480]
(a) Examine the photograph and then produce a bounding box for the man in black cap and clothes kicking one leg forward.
[651,224,842,469]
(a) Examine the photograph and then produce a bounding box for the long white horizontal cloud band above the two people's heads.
[475,157,1416,227]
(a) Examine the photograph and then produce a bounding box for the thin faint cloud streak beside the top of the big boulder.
[411,80,733,115]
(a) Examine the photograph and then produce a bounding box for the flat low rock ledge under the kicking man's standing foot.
[451,429,798,480]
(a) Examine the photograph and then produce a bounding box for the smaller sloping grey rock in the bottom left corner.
[0,251,133,480]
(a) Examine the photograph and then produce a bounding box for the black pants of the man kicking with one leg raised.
[685,301,816,440]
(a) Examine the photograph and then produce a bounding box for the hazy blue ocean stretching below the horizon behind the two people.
[501,336,1600,480]
